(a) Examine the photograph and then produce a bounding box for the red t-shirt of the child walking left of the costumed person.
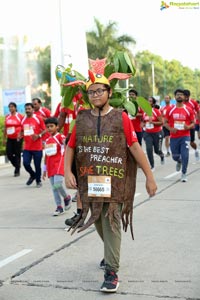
[44,133,66,177]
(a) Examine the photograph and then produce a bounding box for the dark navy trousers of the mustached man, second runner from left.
[23,150,43,183]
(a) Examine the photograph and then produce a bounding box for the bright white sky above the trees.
[0,0,200,69]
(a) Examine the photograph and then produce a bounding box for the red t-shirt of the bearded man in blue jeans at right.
[165,105,194,138]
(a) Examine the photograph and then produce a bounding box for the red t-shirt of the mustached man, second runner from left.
[21,114,46,151]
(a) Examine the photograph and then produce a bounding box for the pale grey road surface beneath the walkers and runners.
[0,151,200,300]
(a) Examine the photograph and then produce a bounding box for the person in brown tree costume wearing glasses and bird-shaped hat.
[65,58,157,292]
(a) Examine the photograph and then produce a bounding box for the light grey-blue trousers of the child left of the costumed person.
[49,175,67,206]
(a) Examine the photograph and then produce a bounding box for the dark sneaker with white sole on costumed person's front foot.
[100,271,119,293]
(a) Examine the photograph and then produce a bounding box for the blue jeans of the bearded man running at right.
[170,136,190,174]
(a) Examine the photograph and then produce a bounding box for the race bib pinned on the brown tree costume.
[88,176,111,198]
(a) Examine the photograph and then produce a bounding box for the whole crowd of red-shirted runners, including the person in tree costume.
[4,85,200,292]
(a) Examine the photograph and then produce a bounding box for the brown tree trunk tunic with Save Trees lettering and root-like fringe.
[69,109,137,239]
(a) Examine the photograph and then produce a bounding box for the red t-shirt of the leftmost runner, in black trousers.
[4,112,23,139]
